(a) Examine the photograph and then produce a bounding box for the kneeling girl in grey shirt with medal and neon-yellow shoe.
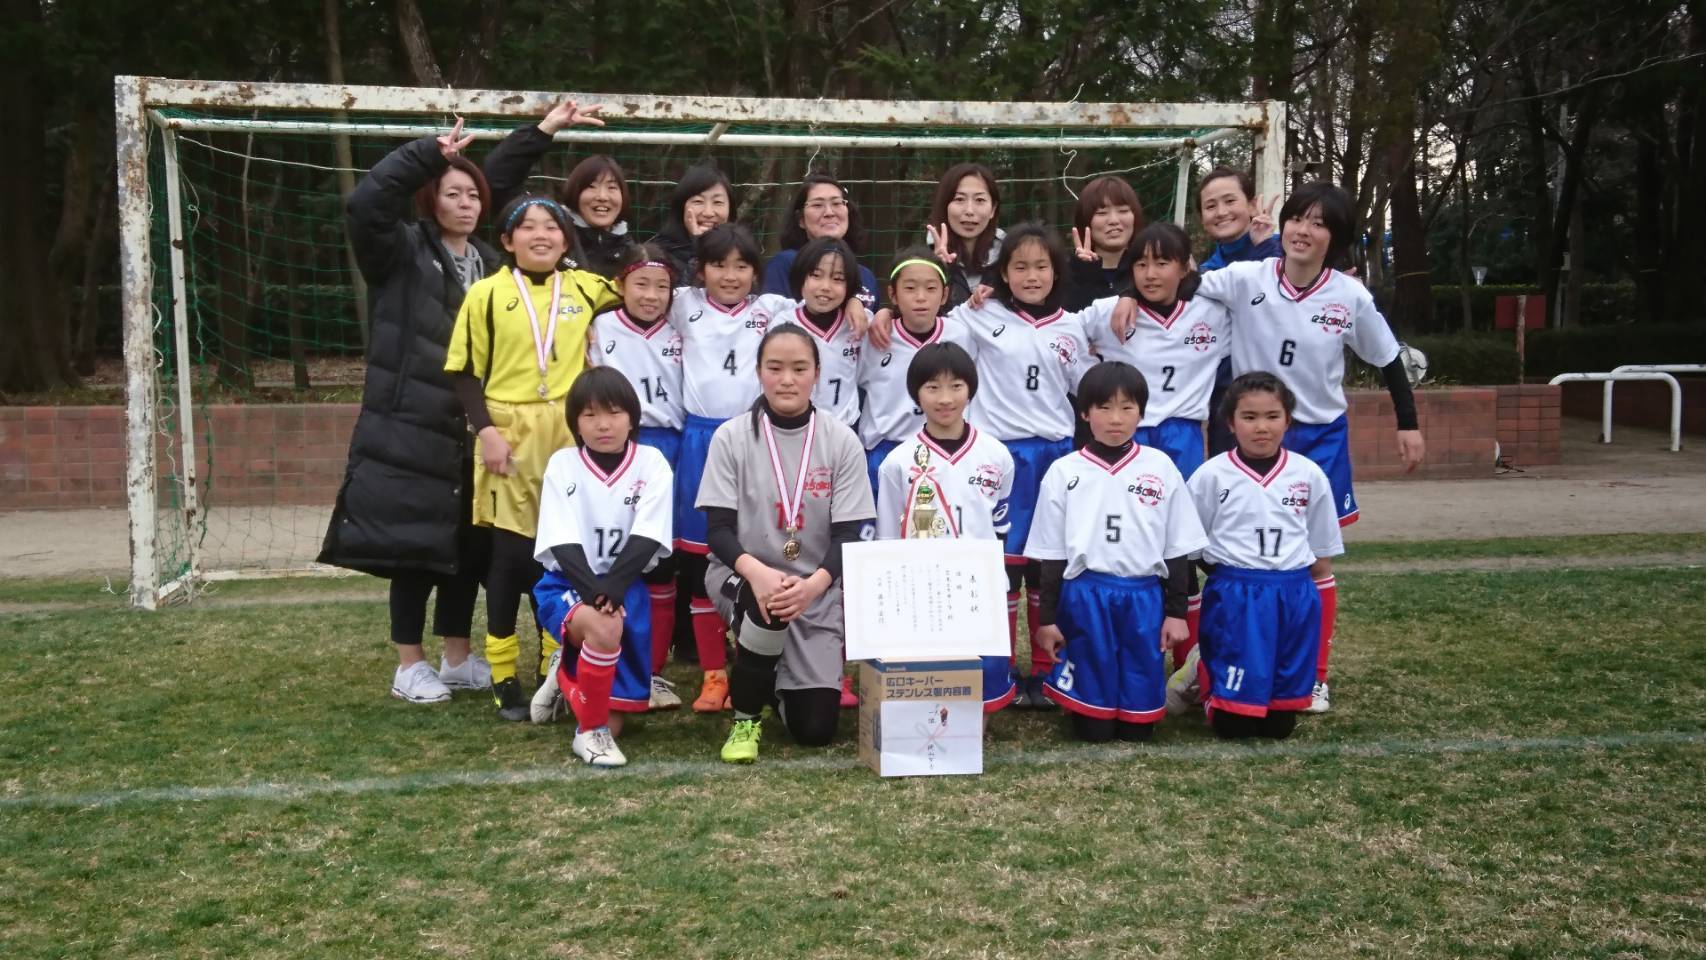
[698,324,875,762]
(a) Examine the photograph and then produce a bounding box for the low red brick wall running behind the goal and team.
[0,387,1562,510]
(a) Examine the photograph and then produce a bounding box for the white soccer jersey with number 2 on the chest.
[1080,297,1232,426]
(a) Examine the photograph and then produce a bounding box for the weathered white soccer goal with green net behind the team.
[114,77,1285,607]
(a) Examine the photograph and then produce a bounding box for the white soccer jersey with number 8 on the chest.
[949,300,1092,440]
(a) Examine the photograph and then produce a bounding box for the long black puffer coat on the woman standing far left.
[319,136,500,576]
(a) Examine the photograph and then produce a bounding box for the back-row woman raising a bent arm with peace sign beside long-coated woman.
[486,101,635,278]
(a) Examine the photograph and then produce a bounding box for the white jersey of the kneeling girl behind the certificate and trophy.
[877,426,1013,541]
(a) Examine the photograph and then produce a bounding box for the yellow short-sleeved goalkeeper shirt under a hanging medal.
[444,268,623,404]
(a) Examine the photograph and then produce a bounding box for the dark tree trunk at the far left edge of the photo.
[0,0,77,390]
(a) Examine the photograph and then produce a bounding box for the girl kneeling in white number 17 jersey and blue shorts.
[1189,372,1344,738]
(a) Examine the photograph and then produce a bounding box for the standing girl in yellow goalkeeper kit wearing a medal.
[444,196,621,721]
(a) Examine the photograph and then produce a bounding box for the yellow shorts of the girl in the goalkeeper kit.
[474,399,575,537]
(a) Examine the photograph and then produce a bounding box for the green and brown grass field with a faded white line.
[0,537,1706,958]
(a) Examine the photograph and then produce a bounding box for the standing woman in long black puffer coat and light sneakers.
[319,121,500,703]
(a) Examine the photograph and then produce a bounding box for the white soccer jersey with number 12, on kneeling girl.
[534,443,676,576]
